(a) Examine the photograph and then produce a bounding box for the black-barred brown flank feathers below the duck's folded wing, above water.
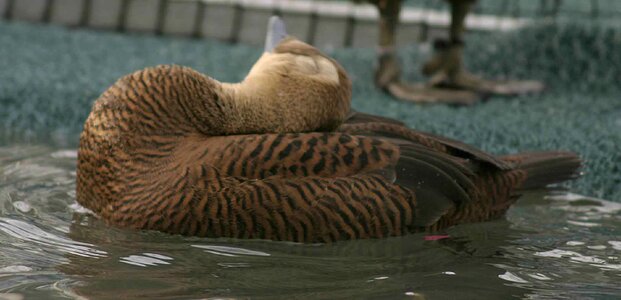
[114,165,416,243]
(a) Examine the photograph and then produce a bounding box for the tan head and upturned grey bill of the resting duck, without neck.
[237,17,351,131]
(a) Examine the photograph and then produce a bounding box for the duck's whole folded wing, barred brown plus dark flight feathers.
[174,132,475,228]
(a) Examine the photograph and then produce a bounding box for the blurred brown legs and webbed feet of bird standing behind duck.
[364,0,544,104]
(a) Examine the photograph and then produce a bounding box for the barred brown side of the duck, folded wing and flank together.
[115,133,472,242]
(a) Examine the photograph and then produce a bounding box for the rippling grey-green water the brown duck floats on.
[0,146,621,299]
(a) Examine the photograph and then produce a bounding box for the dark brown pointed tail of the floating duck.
[501,151,582,190]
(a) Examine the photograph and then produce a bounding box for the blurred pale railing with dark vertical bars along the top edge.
[0,0,621,47]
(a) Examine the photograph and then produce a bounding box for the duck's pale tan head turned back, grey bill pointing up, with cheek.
[220,17,351,133]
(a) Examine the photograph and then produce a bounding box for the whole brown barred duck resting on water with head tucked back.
[76,18,581,243]
